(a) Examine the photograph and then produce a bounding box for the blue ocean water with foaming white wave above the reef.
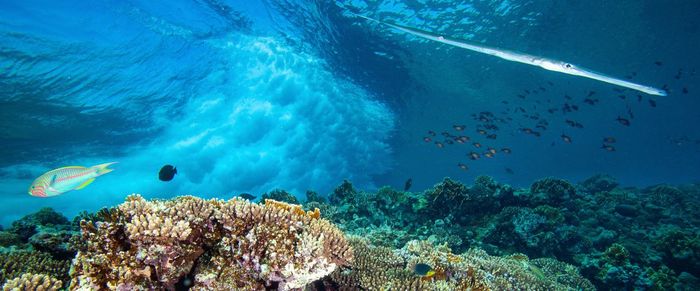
[0,0,700,225]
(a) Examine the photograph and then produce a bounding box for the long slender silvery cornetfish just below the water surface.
[350,12,666,96]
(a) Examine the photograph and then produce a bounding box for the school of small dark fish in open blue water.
[423,61,700,175]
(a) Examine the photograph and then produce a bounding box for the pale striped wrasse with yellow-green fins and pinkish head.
[29,162,116,197]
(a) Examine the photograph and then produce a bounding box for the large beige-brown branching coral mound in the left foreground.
[70,195,353,290]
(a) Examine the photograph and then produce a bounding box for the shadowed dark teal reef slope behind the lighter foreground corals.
[313,175,700,289]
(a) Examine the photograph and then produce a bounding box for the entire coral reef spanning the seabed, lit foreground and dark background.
[0,175,700,290]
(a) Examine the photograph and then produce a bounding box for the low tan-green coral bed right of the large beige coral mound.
[328,237,594,290]
